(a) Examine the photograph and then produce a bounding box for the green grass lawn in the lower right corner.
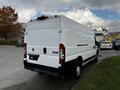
[73,56,120,90]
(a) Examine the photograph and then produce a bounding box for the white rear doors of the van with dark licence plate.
[26,20,61,68]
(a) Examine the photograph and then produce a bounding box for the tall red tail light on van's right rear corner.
[59,44,65,64]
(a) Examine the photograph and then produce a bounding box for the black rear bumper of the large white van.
[23,60,64,76]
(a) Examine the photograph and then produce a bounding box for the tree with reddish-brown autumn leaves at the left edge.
[0,6,20,40]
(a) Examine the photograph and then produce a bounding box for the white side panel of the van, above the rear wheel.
[62,17,97,61]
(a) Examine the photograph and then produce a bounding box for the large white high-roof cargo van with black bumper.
[24,15,98,77]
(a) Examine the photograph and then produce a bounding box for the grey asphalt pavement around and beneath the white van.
[0,46,120,90]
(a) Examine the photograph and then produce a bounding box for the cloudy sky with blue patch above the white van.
[0,0,120,30]
